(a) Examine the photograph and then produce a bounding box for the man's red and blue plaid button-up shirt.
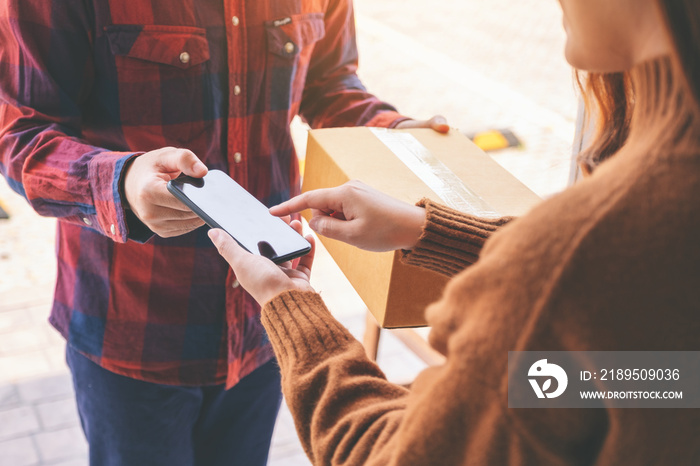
[0,0,401,386]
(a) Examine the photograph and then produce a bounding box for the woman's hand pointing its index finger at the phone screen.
[270,181,425,251]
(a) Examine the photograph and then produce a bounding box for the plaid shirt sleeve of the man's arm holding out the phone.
[0,0,137,242]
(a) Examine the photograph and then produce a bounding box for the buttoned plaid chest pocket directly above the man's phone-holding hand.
[105,25,210,147]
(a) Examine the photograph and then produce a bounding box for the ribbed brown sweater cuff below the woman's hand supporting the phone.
[261,290,354,368]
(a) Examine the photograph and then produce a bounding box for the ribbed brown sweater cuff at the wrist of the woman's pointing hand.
[402,199,513,276]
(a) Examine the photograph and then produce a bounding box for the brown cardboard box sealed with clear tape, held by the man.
[302,128,540,328]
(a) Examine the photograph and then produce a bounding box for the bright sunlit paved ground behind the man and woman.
[0,0,576,466]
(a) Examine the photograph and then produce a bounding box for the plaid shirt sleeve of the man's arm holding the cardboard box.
[300,0,409,128]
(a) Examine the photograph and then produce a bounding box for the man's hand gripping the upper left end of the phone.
[124,147,207,238]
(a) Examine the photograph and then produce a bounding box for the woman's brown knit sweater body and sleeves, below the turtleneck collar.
[262,144,700,466]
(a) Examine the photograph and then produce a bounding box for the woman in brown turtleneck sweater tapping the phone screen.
[210,0,700,465]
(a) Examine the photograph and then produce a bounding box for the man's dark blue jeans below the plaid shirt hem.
[66,346,282,466]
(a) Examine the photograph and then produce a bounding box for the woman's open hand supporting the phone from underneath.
[209,220,316,306]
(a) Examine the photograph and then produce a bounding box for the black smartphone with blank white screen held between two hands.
[168,170,311,264]
